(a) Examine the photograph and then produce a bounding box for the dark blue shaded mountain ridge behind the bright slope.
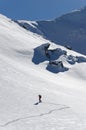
[19,7,86,54]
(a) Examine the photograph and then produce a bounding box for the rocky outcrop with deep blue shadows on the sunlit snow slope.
[32,43,86,73]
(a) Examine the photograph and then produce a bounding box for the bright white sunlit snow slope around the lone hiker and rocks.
[0,15,86,130]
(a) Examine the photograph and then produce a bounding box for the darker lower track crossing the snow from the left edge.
[0,107,70,127]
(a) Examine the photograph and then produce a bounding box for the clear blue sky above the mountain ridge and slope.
[0,0,86,20]
